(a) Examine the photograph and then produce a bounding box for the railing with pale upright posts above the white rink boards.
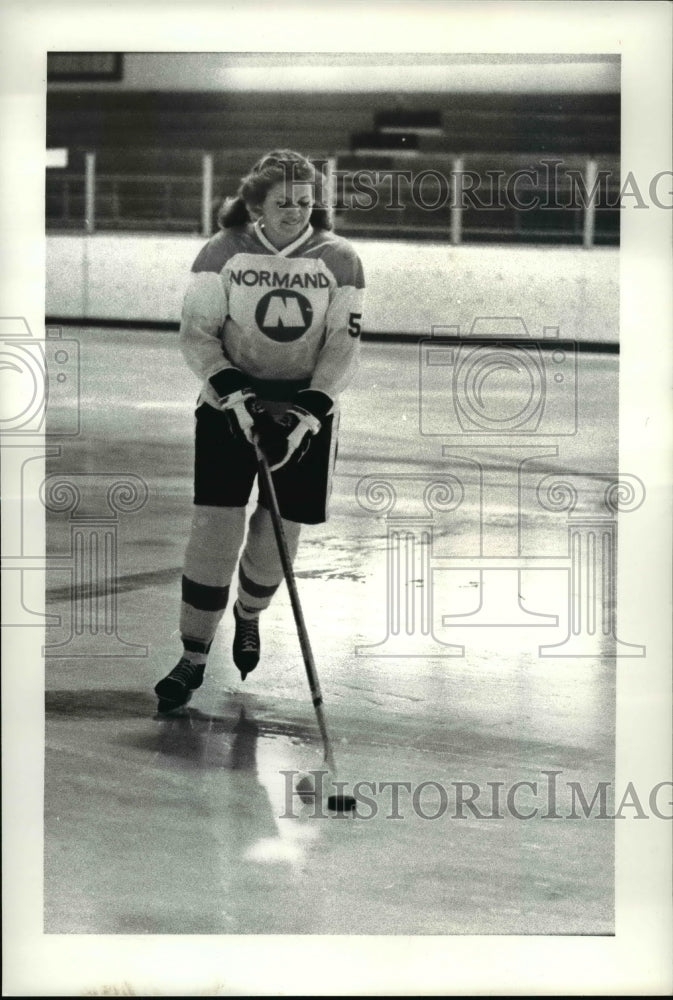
[47,152,619,248]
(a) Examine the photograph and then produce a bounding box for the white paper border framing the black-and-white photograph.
[0,0,673,996]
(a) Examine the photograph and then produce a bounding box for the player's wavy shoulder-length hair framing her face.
[217,149,332,229]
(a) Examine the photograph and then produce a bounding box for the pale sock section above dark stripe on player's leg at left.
[184,505,245,588]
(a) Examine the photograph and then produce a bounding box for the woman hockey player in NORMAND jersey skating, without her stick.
[154,150,364,712]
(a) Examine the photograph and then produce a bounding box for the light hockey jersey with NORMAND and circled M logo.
[180,222,364,405]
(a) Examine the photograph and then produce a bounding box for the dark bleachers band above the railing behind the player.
[47,89,619,162]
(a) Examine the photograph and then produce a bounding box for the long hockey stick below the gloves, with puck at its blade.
[255,442,355,812]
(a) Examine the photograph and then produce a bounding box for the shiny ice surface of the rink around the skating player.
[45,327,629,935]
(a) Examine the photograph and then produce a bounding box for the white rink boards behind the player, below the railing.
[46,234,619,343]
